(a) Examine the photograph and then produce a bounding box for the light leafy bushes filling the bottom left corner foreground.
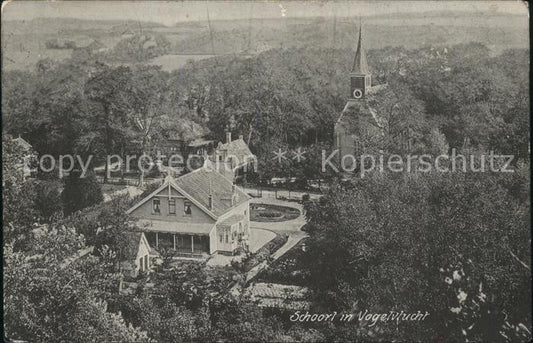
[4,228,147,342]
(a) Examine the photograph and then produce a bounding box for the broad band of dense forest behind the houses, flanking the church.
[2,43,529,179]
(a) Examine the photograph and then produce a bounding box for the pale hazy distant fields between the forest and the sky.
[2,12,529,71]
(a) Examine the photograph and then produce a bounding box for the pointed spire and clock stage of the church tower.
[350,22,372,99]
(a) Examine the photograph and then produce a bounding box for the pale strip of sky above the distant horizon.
[2,0,528,25]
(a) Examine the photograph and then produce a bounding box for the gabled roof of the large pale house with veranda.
[126,165,250,220]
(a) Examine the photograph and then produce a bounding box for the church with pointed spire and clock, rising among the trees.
[333,25,383,174]
